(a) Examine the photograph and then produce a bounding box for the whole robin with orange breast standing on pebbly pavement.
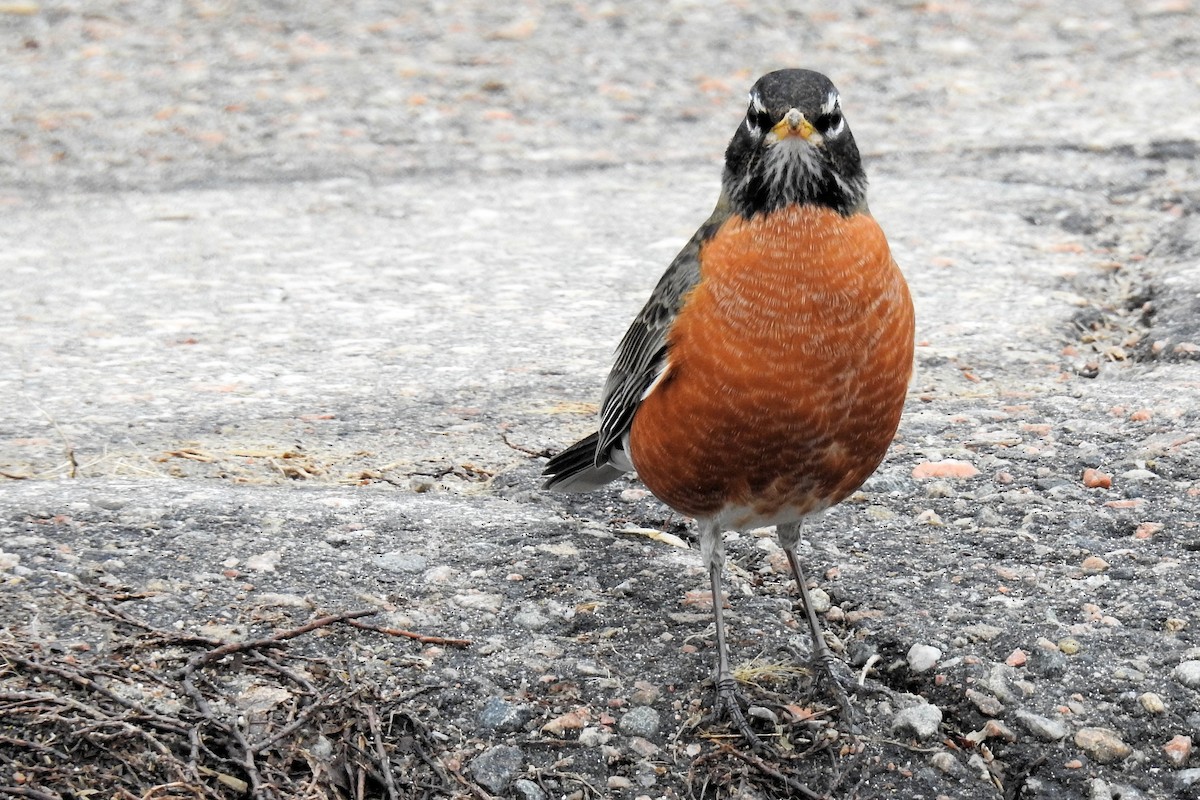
[544,68,914,744]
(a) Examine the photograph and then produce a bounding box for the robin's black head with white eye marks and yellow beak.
[722,70,866,217]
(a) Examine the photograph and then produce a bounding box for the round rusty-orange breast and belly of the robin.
[630,206,913,528]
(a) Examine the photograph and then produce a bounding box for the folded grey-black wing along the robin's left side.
[595,192,730,467]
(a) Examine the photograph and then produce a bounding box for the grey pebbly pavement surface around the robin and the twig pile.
[0,0,1200,800]
